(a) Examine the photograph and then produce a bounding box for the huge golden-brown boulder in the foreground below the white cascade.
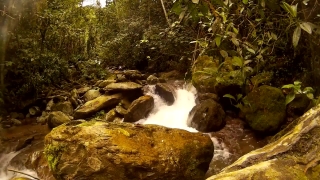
[45,121,214,180]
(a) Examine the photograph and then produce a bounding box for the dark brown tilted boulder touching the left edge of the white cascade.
[124,95,154,122]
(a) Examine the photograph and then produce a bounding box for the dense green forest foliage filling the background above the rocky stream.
[0,0,320,111]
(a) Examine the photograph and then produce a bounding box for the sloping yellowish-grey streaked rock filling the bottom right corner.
[207,105,320,180]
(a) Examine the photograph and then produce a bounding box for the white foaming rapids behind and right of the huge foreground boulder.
[137,85,230,160]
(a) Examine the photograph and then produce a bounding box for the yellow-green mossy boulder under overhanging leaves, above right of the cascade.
[192,56,244,96]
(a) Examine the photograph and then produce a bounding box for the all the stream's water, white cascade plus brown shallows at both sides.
[0,83,265,180]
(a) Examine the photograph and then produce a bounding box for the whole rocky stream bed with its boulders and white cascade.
[0,68,320,180]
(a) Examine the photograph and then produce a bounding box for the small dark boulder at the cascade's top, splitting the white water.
[155,83,175,106]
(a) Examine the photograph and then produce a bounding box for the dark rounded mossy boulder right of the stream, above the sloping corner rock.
[241,85,286,133]
